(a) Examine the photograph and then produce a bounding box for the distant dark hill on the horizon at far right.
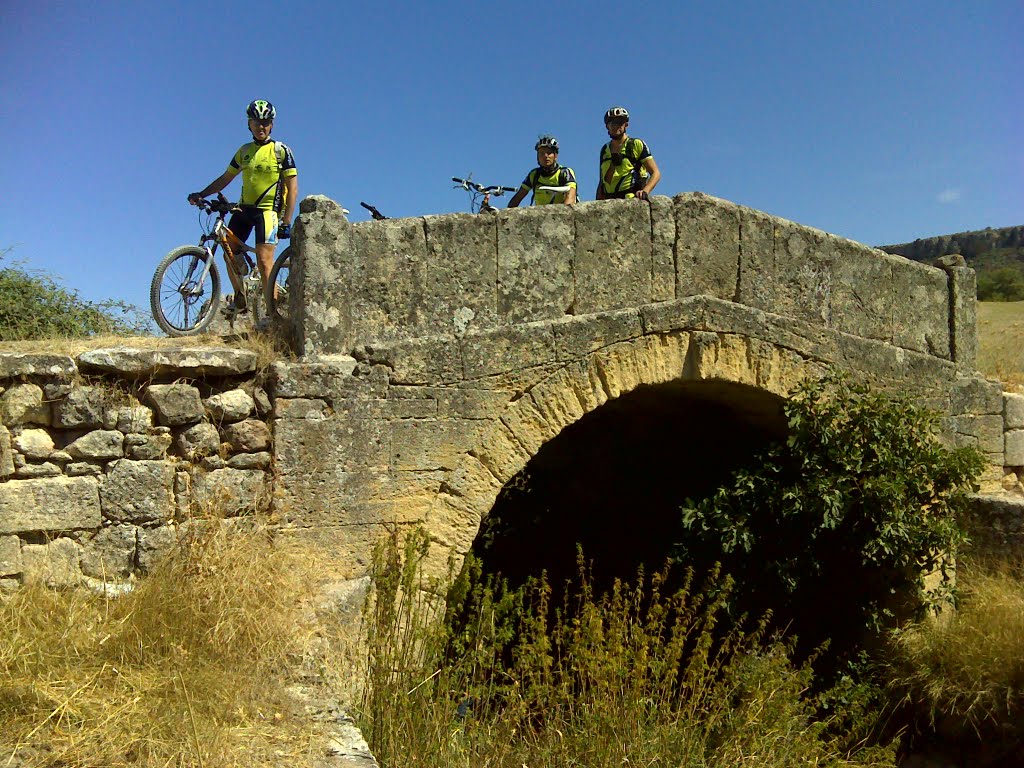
[879,226,1024,301]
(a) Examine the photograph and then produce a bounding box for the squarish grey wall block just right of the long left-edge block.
[99,459,175,524]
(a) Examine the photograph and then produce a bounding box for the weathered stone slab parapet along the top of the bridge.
[293,193,977,370]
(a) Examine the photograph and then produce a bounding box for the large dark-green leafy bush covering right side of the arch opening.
[678,376,983,672]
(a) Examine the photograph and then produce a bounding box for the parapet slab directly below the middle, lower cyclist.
[498,205,575,326]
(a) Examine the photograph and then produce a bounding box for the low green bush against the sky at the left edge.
[0,249,148,341]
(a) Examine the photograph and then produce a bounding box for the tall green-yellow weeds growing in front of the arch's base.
[360,535,893,768]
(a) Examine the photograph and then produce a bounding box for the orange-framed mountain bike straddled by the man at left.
[150,194,288,336]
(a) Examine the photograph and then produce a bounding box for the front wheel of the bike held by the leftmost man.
[150,246,220,336]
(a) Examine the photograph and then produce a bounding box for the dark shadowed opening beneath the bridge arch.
[472,381,786,590]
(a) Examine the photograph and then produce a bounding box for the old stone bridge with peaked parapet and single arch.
[273,193,1024,578]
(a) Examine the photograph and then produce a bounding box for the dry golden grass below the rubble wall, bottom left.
[0,520,325,768]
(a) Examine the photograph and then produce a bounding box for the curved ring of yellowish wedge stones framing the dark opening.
[427,331,825,558]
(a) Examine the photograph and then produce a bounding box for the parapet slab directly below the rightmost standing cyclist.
[570,200,653,314]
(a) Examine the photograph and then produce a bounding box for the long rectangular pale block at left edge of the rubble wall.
[0,477,102,535]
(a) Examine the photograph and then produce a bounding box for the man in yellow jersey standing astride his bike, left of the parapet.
[188,98,299,312]
